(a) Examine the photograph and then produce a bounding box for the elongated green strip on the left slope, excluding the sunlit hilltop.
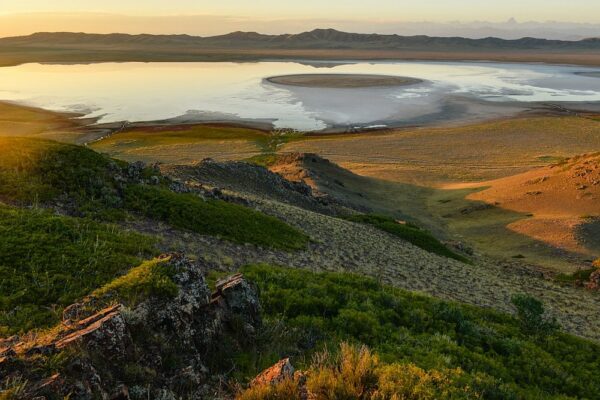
[125,185,308,250]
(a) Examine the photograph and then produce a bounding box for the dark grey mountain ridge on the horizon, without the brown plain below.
[0,29,600,51]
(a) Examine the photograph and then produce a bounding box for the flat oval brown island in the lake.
[265,74,422,89]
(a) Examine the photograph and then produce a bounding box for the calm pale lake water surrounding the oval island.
[0,62,600,130]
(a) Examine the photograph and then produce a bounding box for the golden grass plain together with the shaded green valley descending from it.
[281,117,600,272]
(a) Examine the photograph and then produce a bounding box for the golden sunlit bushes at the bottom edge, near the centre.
[237,343,479,400]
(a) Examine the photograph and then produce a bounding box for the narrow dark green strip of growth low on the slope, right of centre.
[346,214,470,263]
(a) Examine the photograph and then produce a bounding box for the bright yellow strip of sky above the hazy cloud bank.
[0,0,600,22]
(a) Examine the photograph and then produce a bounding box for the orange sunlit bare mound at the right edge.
[467,154,600,256]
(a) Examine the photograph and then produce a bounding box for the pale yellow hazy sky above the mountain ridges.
[0,0,600,36]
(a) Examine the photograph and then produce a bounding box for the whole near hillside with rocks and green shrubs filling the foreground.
[0,138,600,400]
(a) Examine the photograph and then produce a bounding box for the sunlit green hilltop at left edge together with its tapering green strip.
[0,138,308,250]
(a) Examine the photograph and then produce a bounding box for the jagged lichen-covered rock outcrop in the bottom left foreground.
[0,254,261,400]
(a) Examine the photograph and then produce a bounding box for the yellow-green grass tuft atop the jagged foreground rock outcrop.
[92,258,179,306]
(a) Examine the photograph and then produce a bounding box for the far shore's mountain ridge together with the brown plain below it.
[0,29,600,65]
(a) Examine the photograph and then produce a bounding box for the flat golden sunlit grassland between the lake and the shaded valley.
[281,116,600,186]
